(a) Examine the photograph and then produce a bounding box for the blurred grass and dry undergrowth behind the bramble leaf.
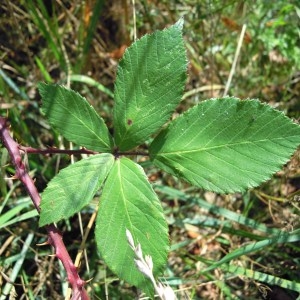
[0,0,300,299]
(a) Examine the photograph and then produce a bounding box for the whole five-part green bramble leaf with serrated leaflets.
[2,19,300,295]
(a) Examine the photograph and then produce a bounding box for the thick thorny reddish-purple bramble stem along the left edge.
[0,117,89,300]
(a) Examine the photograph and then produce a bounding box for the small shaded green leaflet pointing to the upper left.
[39,83,113,152]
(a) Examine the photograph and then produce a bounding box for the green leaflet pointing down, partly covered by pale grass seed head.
[95,158,169,291]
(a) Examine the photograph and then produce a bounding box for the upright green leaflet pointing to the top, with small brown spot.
[113,19,187,151]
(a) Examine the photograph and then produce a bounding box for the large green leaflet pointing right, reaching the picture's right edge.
[150,97,300,193]
